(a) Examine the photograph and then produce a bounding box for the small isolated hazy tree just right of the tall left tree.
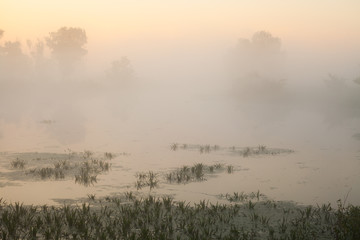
[107,57,134,81]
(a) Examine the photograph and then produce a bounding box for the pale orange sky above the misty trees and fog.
[0,0,360,76]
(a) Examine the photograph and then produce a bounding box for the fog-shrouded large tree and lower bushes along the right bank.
[227,31,360,130]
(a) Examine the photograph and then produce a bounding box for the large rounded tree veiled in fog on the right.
[230,31,285,96]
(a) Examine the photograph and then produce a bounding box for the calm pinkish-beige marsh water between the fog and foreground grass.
[0,85,360,207]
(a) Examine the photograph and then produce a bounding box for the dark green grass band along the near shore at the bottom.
[0,195,360,240]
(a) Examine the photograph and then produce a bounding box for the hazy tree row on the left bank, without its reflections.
[0,27,133,81]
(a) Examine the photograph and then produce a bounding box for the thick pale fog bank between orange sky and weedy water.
[0,22,360,203]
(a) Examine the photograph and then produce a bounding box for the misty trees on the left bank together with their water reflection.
[0,27,134,143]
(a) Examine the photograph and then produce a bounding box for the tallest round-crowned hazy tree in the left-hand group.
[46,27,87,75]
